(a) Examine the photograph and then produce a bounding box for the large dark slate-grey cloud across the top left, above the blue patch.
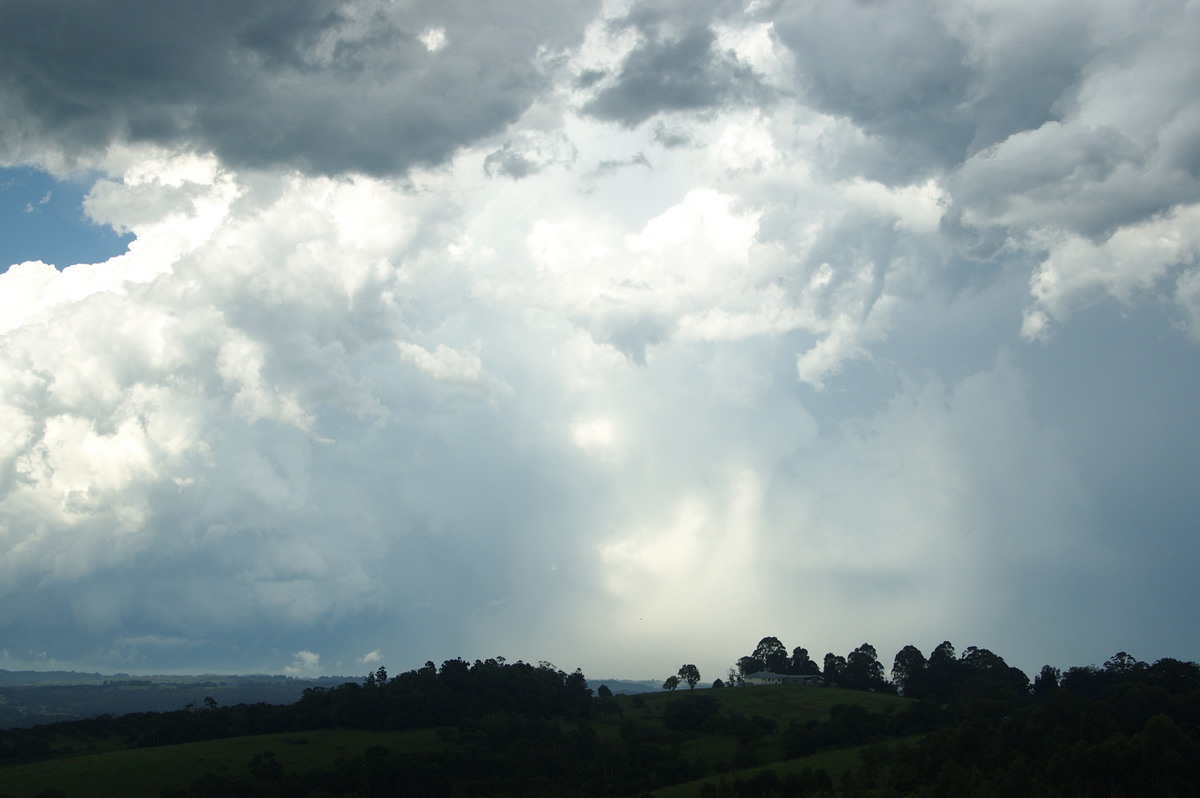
[0,0,600,174]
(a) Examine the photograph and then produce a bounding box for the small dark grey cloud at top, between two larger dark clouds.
[583,28,768,127]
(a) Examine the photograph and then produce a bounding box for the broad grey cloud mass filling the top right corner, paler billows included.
[774,0,1200,240]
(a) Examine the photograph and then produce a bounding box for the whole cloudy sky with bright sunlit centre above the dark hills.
[0,0,1200,679]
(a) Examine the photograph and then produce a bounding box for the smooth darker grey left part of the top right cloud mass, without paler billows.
[775,0,1092,177]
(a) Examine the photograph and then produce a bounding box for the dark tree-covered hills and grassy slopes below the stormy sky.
[0,638,1200,798]
